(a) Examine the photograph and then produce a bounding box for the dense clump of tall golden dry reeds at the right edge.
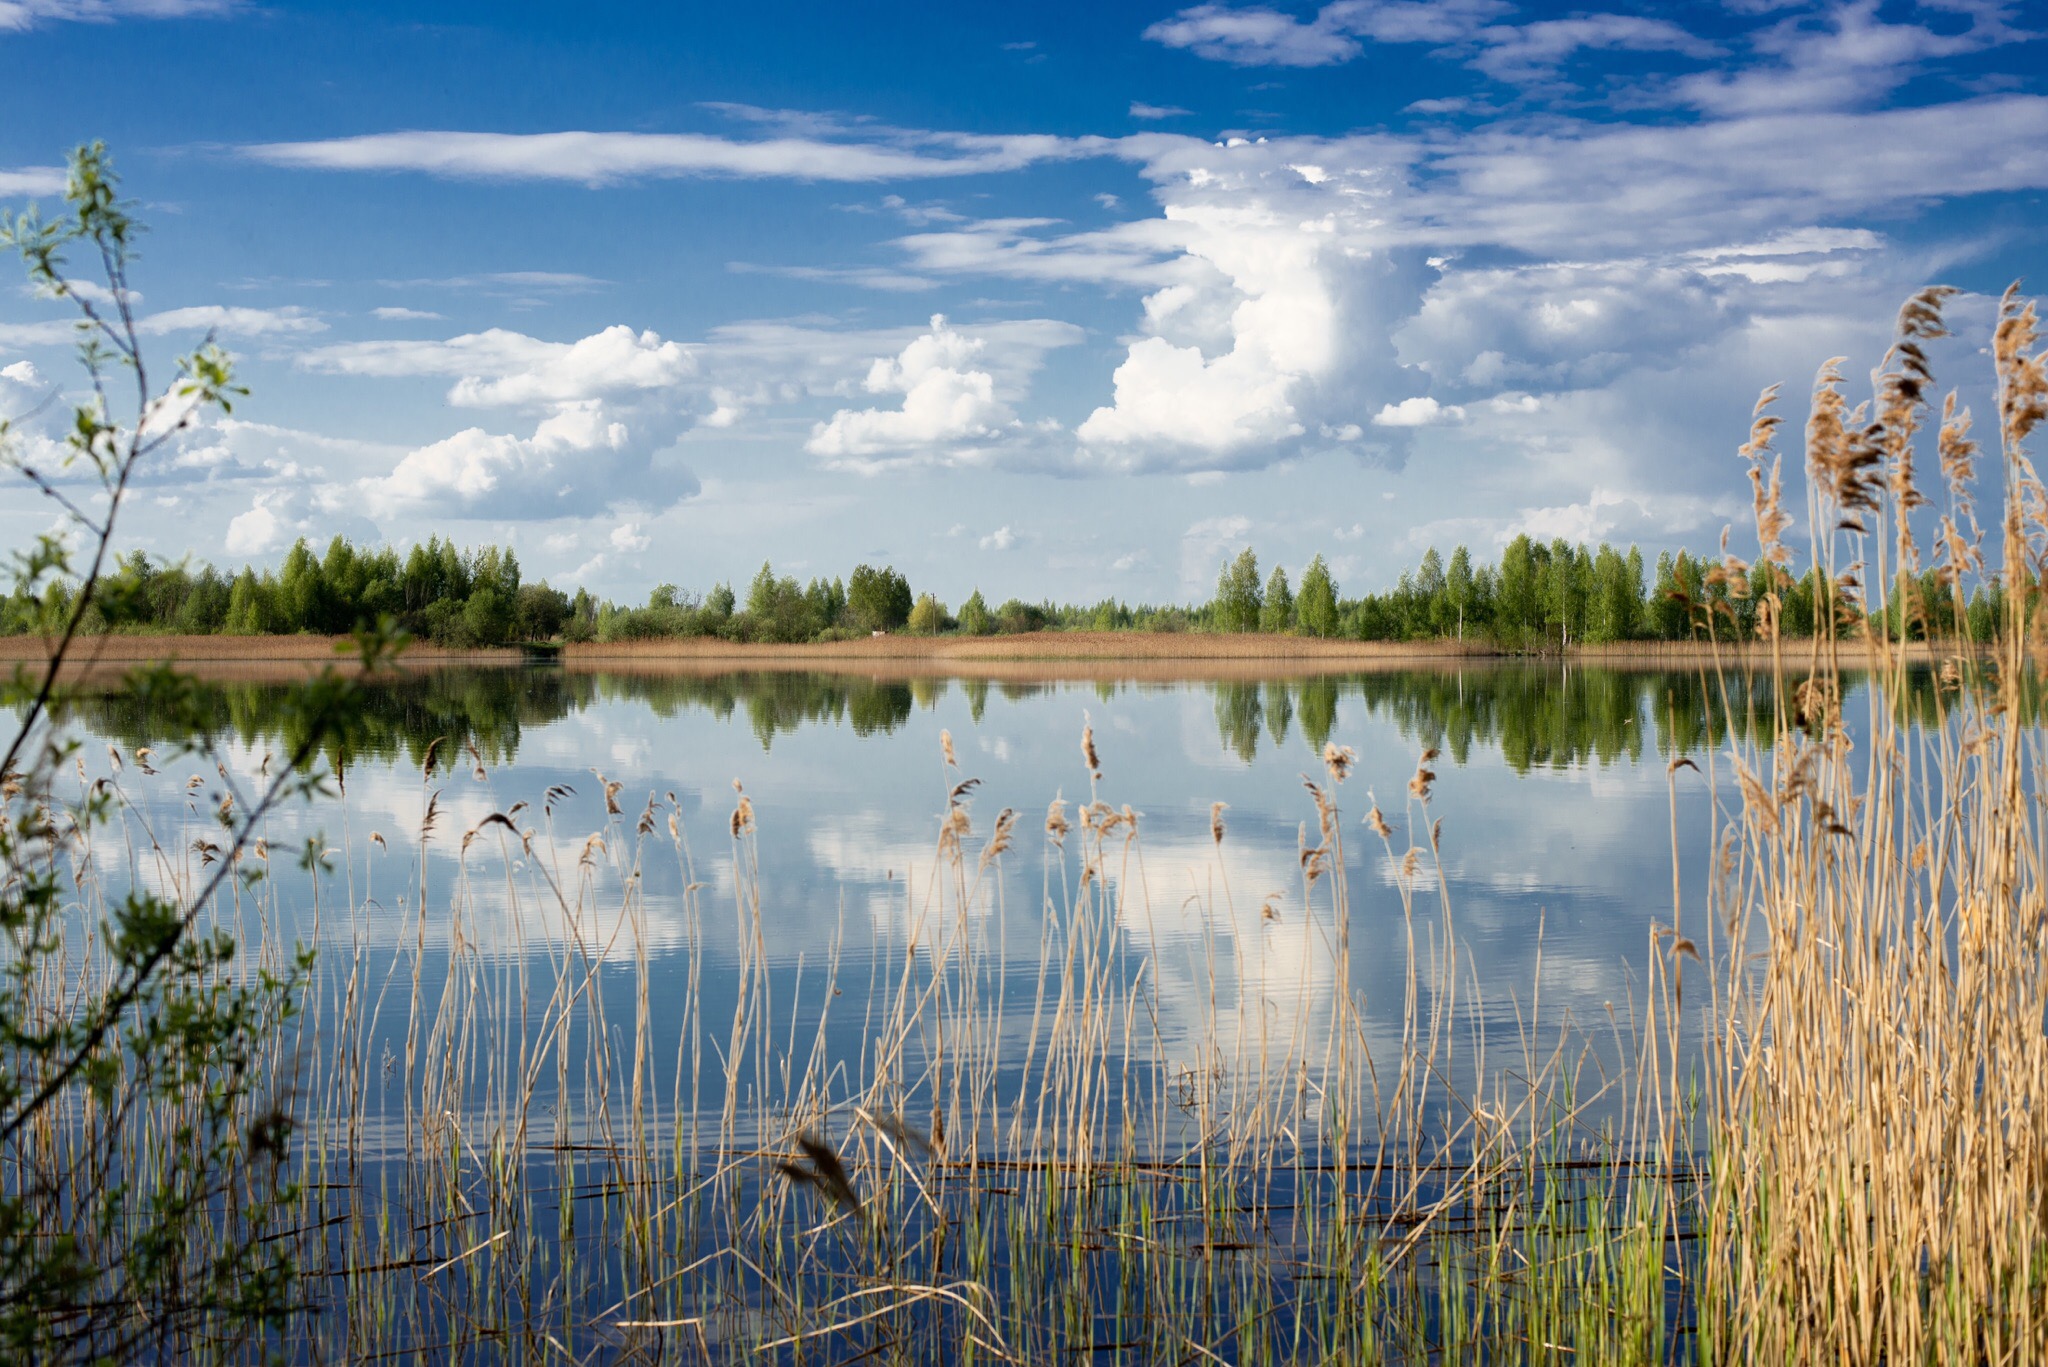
[1702,282,2048,1363]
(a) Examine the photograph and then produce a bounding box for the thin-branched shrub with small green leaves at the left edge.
[0,143,401,1363]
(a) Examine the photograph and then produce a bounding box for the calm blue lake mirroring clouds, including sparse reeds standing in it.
[24,662,1884,1361]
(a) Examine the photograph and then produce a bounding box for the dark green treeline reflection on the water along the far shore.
[48,664,1939,775]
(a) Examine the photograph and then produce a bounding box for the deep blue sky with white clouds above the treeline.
[0,0,2048,605]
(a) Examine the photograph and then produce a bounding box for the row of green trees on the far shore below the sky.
[0,537,2003,650]
